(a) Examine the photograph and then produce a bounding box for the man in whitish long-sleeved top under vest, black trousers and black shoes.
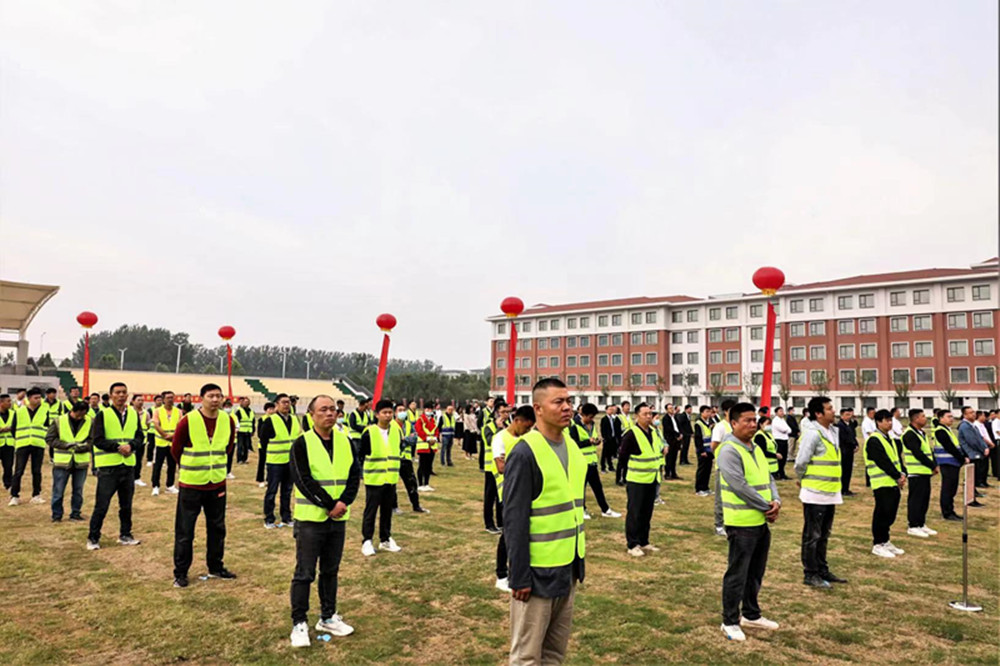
[795,396,847,588]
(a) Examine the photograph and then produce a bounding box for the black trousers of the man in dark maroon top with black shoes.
[174,487,226,578]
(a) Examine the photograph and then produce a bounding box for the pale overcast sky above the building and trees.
[0,0,998,368]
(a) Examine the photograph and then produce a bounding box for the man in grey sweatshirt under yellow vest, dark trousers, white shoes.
[715,402,781,641]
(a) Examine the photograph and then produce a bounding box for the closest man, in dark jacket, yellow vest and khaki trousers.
[503,377,587,666]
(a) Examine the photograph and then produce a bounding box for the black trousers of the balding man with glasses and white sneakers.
[291,520,347,624]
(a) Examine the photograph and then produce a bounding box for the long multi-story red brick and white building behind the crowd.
[488,258,1000,408]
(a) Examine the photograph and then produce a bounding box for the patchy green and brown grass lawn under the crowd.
[0,444,1000,664]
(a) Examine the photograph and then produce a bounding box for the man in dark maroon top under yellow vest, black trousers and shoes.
[170,384,236,588]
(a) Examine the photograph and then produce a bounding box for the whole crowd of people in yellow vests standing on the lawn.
[0,378,1000,664]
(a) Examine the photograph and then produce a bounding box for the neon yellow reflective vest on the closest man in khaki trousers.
[523,430,587,568]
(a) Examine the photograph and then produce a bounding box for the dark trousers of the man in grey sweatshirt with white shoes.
[722,525,771,625]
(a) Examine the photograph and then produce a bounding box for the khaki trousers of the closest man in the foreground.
[510,582,576,666]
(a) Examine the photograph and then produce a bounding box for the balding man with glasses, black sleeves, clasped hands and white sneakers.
[289,395,361,647]
